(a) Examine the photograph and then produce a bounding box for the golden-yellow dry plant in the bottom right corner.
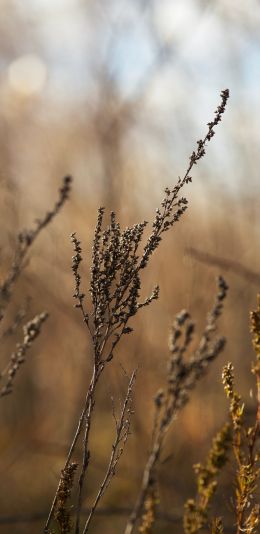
[184,295,260,534]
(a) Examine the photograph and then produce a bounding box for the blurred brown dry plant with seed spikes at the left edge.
[0,176,71,397]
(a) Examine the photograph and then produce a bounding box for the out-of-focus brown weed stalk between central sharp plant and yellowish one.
[125,277,228,534]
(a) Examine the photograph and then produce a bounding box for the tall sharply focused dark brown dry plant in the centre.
[42,89,229,534]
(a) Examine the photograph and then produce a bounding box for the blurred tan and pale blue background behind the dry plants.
[0,0,260,533]
